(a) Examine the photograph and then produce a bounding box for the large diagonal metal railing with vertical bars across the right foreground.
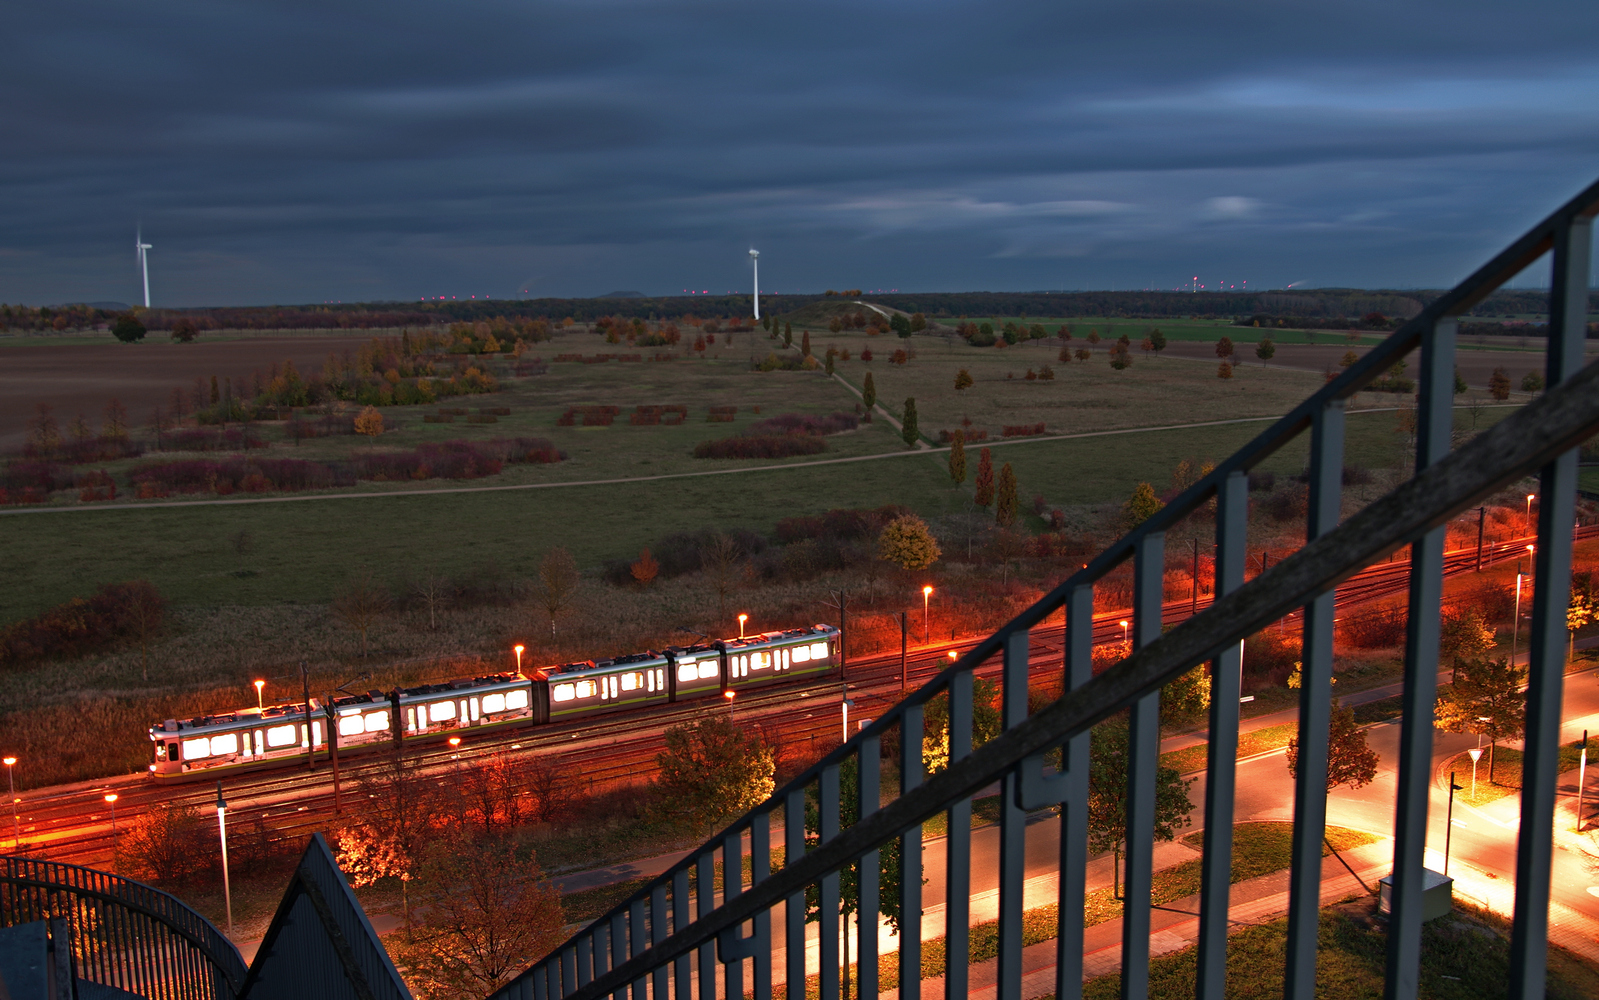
[496,184,1599,1000]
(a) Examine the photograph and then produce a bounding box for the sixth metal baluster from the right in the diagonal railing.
[1055,586,1094,1000]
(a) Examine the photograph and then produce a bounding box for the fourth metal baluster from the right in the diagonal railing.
[1194,472,1249,1000]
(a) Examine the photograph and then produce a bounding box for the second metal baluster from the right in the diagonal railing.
[1386,318,1457,1000]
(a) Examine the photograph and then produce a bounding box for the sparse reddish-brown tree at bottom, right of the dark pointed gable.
[395,837,566,1000]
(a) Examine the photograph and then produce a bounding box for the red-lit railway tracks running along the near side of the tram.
[12,525,1599,867]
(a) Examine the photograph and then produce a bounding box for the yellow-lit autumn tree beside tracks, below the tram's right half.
[656,712,777,830]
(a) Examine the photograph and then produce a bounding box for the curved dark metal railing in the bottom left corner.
[0,856,245,1000]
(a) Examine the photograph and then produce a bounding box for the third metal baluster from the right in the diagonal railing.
[1282,398,1343,1000]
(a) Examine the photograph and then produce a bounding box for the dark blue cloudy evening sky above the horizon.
[0,0,1599,306]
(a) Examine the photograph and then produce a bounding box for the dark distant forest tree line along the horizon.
[0,288,1599,336]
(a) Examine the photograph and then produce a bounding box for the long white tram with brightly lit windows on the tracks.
[149,626,839,781]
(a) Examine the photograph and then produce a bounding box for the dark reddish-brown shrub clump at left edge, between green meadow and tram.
[0,579,166,670]
